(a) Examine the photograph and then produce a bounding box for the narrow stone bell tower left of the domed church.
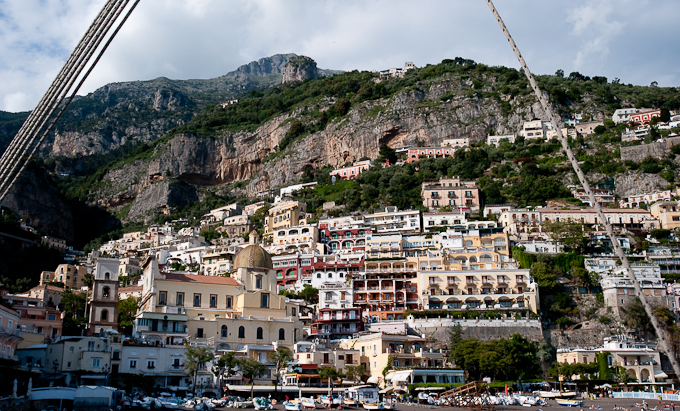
[89,258,119,334]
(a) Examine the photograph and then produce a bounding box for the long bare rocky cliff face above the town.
[91,71,538,225]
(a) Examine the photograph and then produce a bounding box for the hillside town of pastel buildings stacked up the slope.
[0,101,680,410]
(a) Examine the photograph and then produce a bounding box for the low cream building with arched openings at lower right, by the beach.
[557,335,668,384]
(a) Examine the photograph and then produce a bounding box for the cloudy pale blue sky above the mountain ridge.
[0,0,680,112]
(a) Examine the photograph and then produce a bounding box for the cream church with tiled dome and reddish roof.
[136,238,302,350]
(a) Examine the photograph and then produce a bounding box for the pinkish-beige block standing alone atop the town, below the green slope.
[421,177,481,211]
